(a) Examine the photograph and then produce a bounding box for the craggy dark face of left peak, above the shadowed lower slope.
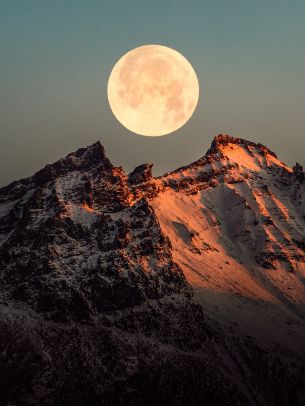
[0,143,190,320]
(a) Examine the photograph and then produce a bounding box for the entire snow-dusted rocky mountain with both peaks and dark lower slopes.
[0,135,305,405]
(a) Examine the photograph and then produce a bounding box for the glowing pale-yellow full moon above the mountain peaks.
[107,45,199,137]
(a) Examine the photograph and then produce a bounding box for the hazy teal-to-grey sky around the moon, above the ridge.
[0,0,305,186]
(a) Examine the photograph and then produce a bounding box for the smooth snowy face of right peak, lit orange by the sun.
[152,135,305,350]
